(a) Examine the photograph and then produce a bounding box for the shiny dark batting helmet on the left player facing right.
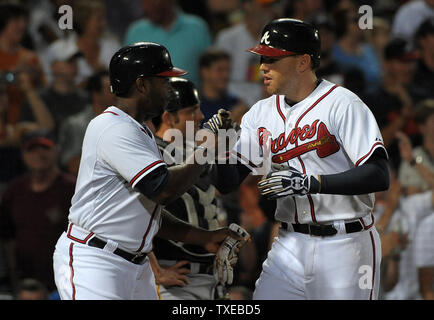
[109,42,187,97]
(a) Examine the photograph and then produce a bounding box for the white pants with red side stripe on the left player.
[53,233,158,300]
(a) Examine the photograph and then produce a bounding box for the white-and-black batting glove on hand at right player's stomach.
[258,167,311,200]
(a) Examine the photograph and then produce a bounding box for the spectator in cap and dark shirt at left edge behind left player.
[0,129,75,292]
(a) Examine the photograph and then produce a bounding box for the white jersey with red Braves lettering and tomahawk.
[234,80,384,225]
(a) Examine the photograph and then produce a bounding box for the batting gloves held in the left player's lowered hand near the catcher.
[214,223,250,285]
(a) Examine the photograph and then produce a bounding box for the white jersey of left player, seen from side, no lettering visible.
[69,106,165,252]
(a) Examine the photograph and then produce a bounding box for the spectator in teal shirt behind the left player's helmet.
[124,0,211,86]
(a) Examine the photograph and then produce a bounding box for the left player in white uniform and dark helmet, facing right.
[53,42,242,300]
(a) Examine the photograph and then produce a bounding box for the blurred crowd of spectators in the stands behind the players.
[0,0,434,300]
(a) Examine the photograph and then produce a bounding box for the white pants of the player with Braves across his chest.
[253,227,381,300]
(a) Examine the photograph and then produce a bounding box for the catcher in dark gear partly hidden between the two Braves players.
[150,78,248,300]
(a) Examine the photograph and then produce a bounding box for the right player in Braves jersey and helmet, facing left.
[227,18,389,299]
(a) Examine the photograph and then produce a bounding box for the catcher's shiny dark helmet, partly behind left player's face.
[166,78,200,111]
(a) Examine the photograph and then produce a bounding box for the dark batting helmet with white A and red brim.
[248,18,321,68]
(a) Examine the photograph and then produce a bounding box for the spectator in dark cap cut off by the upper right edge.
[412,17,434,103]
